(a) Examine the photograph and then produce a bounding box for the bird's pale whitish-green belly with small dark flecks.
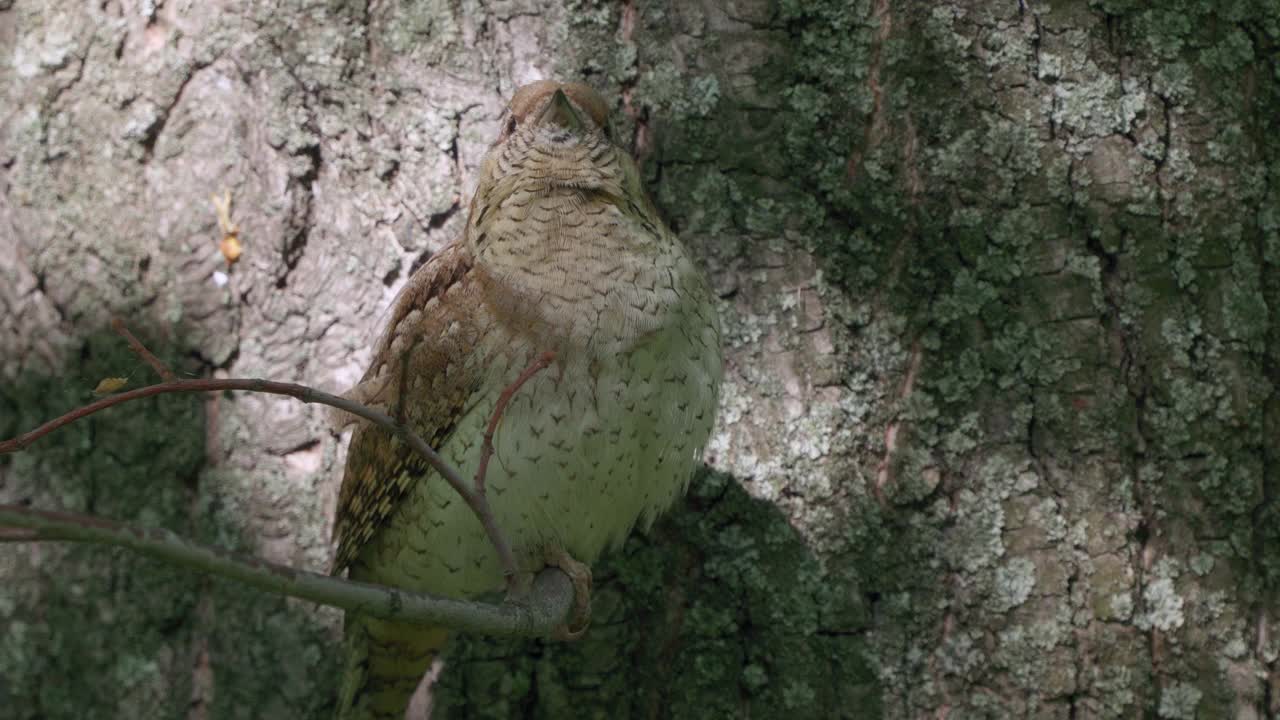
[367,289,721,597]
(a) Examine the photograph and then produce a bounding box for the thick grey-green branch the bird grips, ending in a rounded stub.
[0,505,573,637]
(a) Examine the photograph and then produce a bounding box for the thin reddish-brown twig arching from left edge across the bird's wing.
[0,378,518,577]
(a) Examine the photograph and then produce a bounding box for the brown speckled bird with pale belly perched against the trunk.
[332,79,723,720]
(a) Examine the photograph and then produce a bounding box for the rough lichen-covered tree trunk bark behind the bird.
[0,0,1280,720]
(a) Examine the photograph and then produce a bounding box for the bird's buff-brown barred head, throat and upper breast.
[465,81,691,357]
